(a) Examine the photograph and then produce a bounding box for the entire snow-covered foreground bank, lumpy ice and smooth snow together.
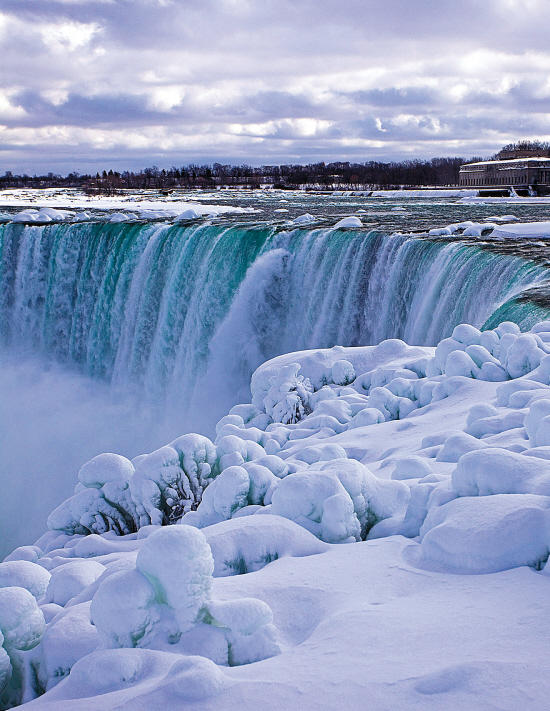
[5,322,550,711]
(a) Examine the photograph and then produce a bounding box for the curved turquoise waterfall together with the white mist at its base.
[0,221,548,552]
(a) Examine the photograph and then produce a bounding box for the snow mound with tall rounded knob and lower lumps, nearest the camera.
[90,526,280,665]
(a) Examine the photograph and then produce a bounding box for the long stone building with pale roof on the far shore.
[459,144,550,195]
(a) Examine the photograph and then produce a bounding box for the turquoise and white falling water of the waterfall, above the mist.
[0,223,548,429]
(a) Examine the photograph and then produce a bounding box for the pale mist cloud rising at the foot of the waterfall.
[0,357,194,559]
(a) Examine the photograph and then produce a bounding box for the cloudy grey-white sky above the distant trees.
[0,0,550,174]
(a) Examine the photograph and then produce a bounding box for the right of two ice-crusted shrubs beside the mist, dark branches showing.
[130,434,217,527]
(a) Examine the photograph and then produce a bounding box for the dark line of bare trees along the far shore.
[0,158,470,193]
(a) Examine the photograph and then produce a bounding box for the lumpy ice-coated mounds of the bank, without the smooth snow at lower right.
[7,322,550,706]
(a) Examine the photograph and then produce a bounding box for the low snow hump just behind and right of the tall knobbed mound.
[203,515,328,577]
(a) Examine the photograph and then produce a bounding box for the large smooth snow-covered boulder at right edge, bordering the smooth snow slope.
[420,494,550,574]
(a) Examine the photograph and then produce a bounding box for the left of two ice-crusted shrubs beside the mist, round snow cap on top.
[48,453,137,535]
